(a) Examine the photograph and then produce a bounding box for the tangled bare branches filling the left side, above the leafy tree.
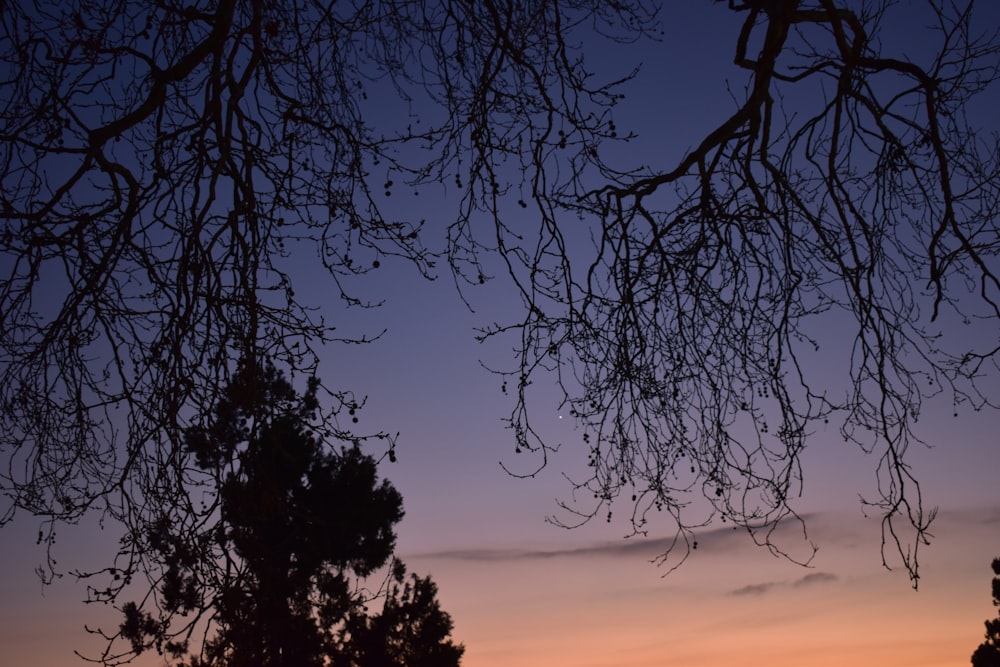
[0,0,652,652]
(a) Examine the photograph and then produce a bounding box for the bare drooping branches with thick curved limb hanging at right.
[451,0,1000,585]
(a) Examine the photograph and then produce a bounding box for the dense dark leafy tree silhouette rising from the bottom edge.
[102,366,463,667]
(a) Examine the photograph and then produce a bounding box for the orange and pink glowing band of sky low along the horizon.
[0,510,1000,667]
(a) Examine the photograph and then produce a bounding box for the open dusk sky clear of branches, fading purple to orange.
[0,2,1000,667]
